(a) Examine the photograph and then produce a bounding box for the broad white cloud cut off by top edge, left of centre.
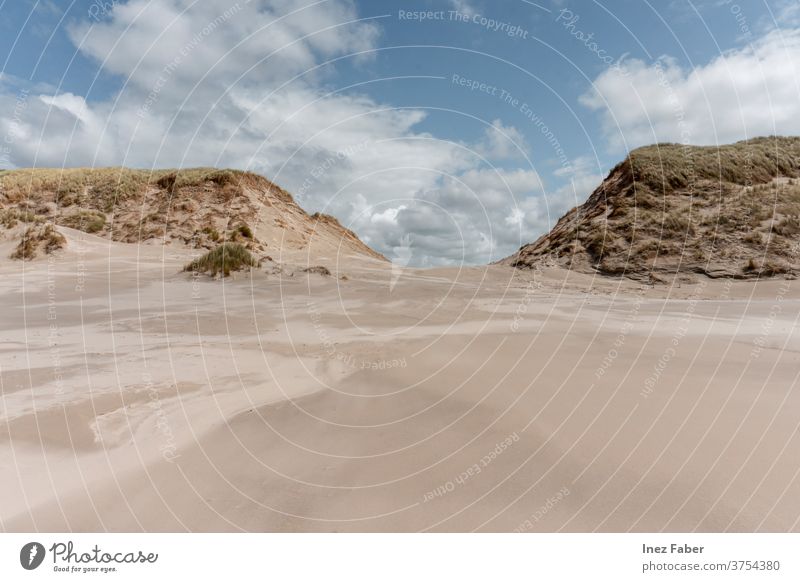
[69,0,378,92]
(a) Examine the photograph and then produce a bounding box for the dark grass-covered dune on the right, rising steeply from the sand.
[507,137,800,277]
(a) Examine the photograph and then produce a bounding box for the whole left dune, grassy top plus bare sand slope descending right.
[0,168,385,260]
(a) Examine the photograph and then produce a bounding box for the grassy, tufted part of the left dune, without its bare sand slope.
[0,168,278,248]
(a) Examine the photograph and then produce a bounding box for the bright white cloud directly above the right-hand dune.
[581,30,800,148]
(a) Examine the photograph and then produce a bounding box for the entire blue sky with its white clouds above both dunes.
[0,0,800,265]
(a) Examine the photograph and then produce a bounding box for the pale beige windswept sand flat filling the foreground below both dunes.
[0,233,800,531]
